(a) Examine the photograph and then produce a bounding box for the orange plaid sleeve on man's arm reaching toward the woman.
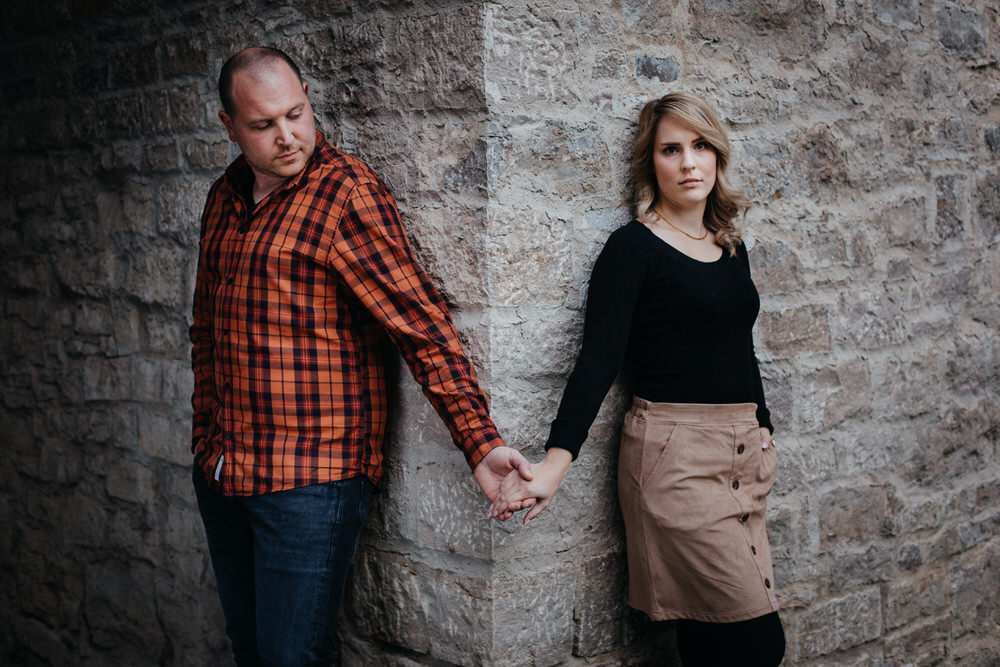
[330,181,503,468]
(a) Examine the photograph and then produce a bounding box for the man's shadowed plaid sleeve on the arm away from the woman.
[189,184,218,451]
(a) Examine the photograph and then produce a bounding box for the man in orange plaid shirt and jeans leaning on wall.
[191,47,531,665]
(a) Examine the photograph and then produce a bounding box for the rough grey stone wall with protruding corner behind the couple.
[0,0,1000,666]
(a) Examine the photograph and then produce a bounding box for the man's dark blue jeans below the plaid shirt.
[193,467,375,667]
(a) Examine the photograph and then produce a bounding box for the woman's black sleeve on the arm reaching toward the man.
[545,230,643,459]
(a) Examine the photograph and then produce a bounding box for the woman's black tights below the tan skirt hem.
[677,612,785,667]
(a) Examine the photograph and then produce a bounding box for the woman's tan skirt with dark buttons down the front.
[618,398,778,623]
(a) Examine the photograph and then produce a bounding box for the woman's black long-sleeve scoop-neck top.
[545,220,773,458]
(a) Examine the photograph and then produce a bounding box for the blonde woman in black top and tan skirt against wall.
[493,93,785,667]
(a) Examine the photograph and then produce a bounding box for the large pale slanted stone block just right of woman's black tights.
[789,588,882,662]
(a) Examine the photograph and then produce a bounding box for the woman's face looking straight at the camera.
[653,116,715,212]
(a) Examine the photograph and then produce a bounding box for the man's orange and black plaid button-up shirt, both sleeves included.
[191,133,503,496]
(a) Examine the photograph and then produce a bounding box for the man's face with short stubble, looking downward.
[219,61,316,185]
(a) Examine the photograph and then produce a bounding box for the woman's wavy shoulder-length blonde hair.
[632,92,750,255]
